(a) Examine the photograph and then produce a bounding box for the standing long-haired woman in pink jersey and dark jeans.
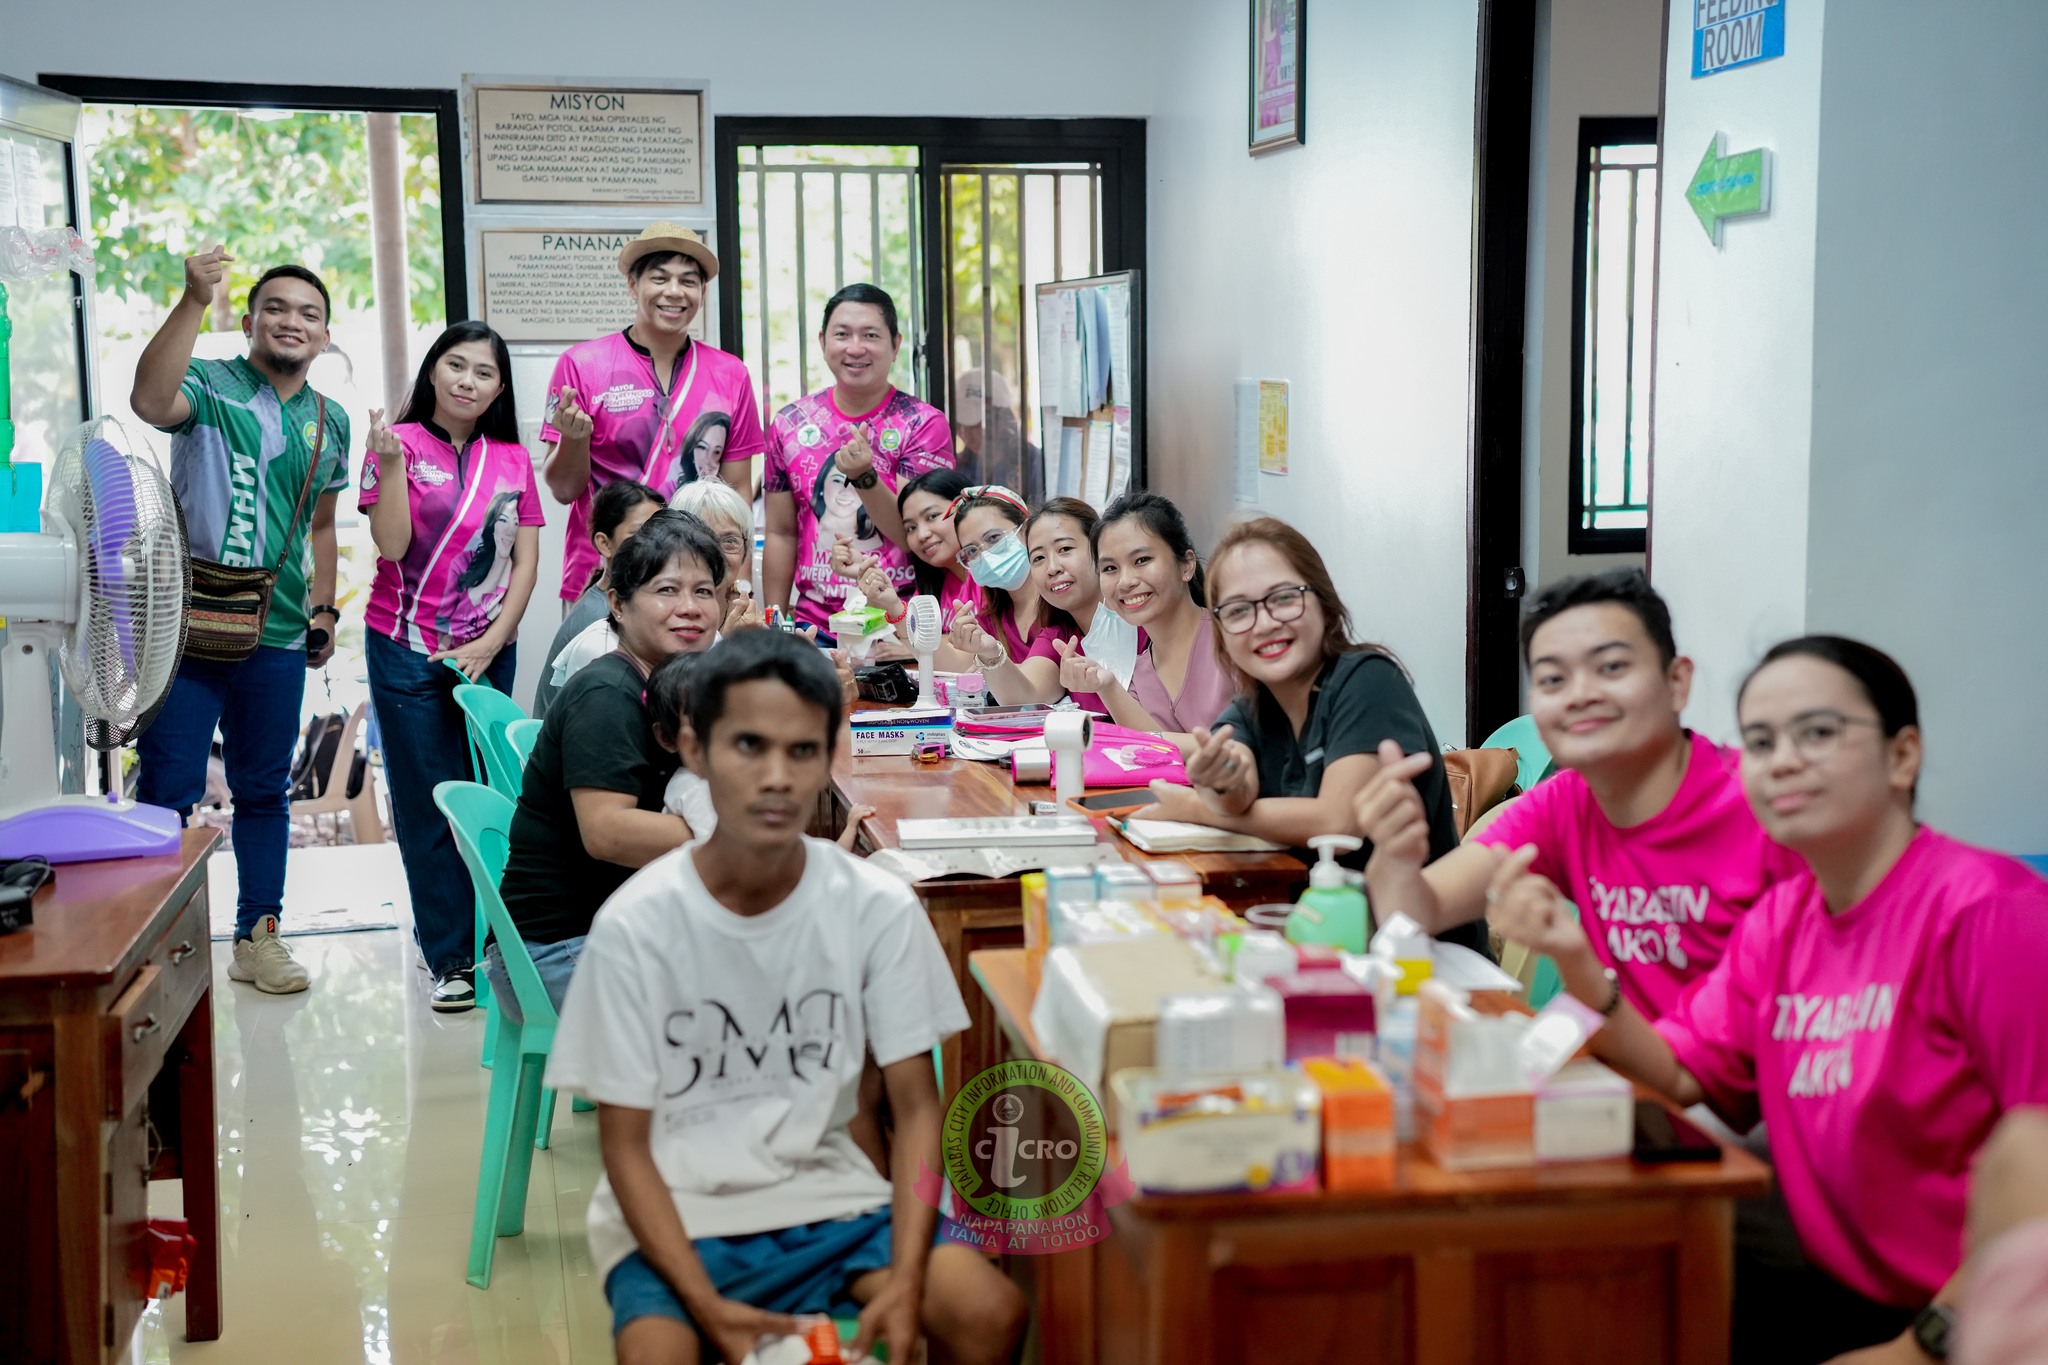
[358,321,543,1013]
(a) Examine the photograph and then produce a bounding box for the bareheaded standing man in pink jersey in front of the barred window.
[762,284,952,634]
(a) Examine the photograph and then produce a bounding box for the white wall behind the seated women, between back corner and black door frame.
[1147,0,1479,743]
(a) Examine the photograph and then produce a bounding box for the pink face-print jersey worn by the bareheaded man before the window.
[762,389,952,630]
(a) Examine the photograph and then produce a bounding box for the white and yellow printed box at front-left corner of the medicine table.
[1112,1070,1323,1195]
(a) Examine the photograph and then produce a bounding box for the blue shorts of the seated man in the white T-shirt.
[604,1205,944,1336]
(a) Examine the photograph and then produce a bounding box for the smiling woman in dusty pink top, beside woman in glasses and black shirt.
[1059,491,1237,753]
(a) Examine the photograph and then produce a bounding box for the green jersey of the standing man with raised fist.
[164,356,348,649]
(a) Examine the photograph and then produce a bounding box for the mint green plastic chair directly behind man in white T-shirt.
[434,782,573,1289]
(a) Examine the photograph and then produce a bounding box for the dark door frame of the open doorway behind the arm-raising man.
[37,72,469,325]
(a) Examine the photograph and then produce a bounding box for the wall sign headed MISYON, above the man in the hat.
[471,86,705,205]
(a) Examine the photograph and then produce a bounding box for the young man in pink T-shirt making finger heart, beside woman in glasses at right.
[1356,569,1798,1019]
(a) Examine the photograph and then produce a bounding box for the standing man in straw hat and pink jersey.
[541,223,764,602]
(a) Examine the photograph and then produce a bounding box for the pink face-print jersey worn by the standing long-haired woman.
[356,422,543,655]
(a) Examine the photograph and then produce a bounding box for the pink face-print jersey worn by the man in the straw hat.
[541,332,762,600]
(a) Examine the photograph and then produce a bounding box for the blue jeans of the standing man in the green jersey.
[135,647,305,939]
